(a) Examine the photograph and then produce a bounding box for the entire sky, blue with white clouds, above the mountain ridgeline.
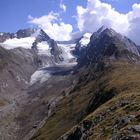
[0,0,140,44]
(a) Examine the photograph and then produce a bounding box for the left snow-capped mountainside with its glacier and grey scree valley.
[0,29,89,140]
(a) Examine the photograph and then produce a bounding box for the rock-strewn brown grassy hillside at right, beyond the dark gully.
[62,62,140,140]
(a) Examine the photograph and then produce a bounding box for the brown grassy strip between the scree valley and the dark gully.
[32,81,93,140]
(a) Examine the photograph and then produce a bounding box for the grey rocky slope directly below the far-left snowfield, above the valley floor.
[0,47,38,100]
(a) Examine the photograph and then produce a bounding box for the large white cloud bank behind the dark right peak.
[76,0,140,44]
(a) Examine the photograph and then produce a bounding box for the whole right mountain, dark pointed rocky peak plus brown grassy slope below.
[32,26,140,140]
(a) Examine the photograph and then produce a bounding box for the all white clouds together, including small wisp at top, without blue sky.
[28,0,140,44]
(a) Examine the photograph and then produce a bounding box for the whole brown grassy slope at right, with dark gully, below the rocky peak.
[32,61,140,140]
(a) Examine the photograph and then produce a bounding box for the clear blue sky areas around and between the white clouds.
[0,0,139,32]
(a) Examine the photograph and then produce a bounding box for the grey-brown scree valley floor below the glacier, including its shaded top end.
[0,63,75,140]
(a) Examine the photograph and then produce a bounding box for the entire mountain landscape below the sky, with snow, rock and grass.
[0,26,140,140]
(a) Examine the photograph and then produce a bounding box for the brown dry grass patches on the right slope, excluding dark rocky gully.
[32,62,140,140]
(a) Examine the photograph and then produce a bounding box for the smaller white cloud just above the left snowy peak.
[29,12,73,41]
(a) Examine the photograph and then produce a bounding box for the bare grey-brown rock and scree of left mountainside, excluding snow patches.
[0,32,78,140]
